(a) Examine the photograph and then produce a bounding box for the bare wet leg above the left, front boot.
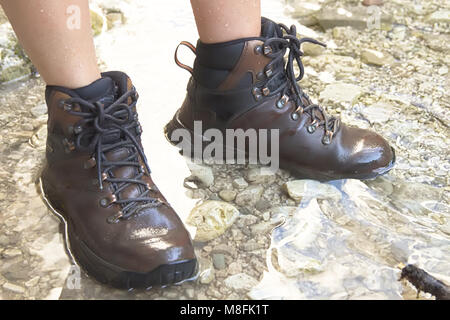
[0,0,100,88]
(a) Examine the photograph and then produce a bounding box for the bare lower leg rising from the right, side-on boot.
[191,0,261,43]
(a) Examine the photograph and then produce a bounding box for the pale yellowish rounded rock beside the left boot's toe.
[186,200,239,241]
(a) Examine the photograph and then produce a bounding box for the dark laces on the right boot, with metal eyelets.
[260,23,340,144]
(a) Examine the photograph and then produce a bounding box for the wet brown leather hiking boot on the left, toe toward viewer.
[41,72,197,289]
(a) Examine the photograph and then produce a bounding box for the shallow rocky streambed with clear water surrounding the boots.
[0,0,450,299]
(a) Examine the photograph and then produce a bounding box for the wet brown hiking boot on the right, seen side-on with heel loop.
[165,18,395,181]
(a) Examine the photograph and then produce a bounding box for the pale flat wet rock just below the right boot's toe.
[284,180,342,201]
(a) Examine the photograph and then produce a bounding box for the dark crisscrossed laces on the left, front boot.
[60,88,166,223]
